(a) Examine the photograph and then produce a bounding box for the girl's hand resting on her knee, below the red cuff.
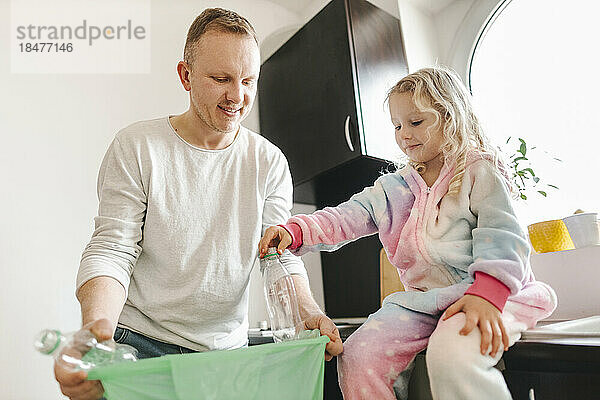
[442,294,508,357]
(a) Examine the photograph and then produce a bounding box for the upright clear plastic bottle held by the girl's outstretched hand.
[260,247,303,342]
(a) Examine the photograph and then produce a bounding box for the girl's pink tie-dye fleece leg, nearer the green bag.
[338,303,437,400]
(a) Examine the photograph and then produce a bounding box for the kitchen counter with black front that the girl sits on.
[249,316,600,400]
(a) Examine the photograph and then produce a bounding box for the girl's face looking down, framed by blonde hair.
[389,92,444,164]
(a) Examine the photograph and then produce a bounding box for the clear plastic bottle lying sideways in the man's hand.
[34,329,137,371]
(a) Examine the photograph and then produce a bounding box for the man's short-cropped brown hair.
[183,8,258,65]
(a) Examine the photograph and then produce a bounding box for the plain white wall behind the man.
[0,0,323,400]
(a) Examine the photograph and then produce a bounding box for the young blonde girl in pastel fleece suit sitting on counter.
[259,67,556,400]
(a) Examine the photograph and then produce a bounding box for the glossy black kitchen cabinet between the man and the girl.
[258,0,408,318]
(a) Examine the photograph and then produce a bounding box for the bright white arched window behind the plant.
[469,0,600,225]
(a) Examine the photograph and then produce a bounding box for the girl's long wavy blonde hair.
[387,66,512,194]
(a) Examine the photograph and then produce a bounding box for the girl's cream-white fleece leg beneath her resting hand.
[425,311,526,400]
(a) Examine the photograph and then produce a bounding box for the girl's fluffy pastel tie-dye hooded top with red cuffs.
[284,154,556,326]
